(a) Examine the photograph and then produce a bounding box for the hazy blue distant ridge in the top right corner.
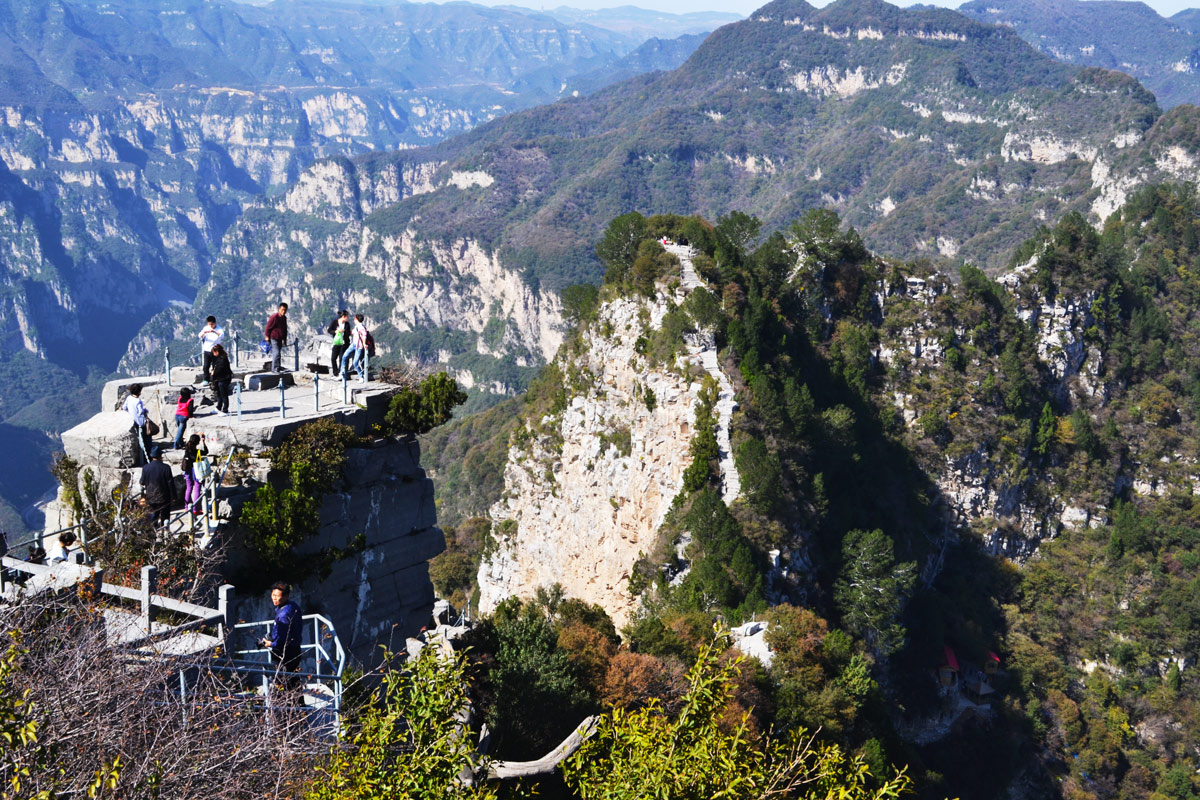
[958,0,1200,108]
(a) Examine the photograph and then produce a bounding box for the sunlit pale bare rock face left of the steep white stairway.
[479,291,704,625]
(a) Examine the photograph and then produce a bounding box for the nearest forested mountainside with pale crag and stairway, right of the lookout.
[431,186,1200,800]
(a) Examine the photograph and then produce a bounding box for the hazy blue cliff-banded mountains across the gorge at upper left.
[0,0,698,525]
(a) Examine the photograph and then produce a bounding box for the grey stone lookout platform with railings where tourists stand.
[43,359,445,663]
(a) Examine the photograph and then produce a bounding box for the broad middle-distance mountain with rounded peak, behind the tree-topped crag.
[147,0,1196,419]
